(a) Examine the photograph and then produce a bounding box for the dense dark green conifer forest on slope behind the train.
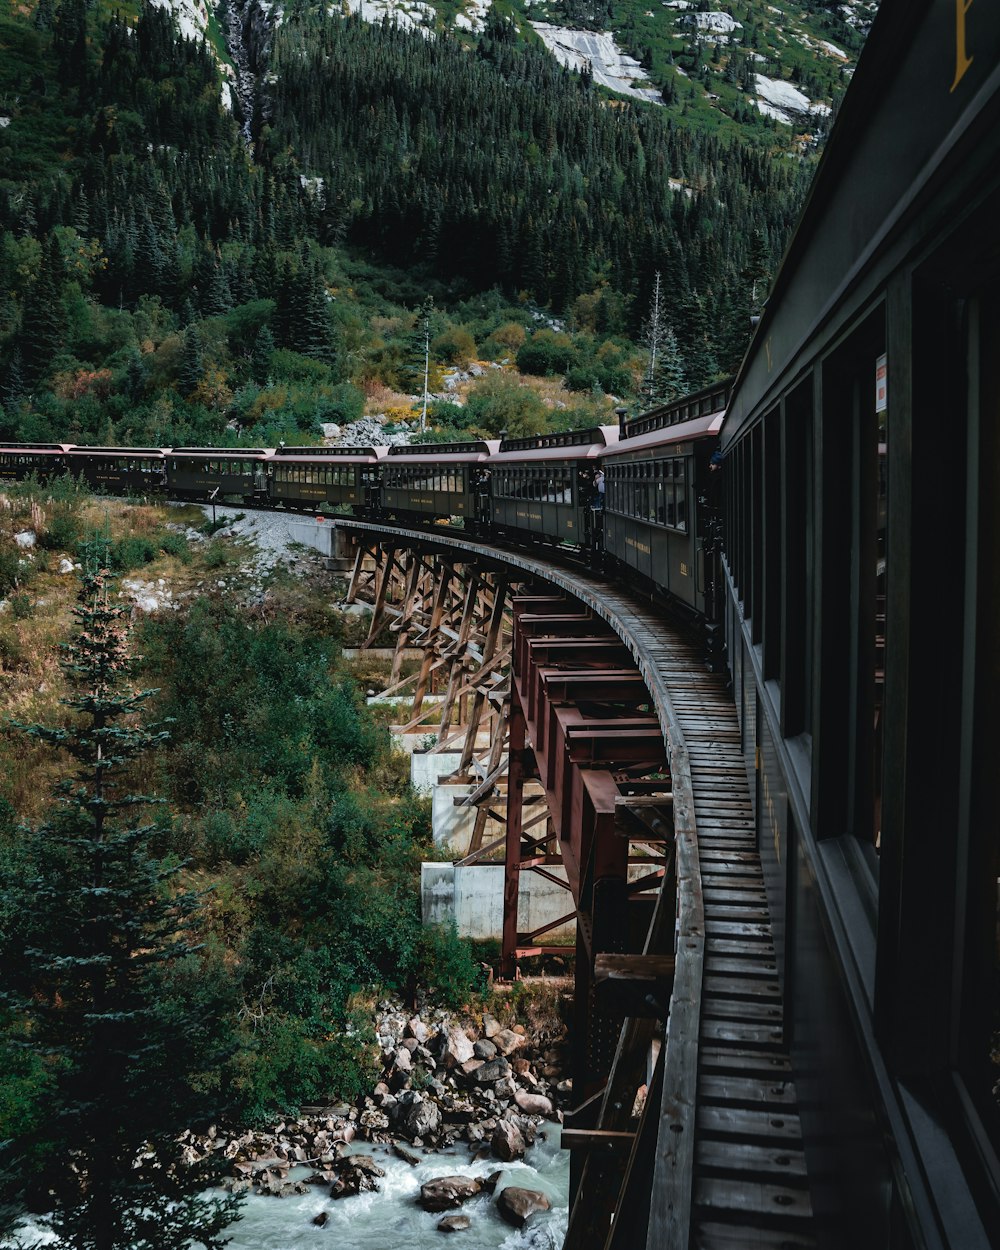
[0,0,835,445]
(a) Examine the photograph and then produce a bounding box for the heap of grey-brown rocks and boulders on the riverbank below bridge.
[192,1003,571,1231]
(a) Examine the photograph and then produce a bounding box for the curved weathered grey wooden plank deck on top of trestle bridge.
[338,521,816,1250]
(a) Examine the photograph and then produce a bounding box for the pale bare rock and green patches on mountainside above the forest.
[166,0,878,146]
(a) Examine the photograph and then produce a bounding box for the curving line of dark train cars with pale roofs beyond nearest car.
[0,381,730,618]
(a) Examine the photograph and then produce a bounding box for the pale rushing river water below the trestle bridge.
[5,1140,570,1250]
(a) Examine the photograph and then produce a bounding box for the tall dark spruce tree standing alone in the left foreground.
[0,569,239,1250]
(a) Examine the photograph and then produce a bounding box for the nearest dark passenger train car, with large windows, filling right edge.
[721,0,1000,1250]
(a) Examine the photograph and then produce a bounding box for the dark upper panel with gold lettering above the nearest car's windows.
[723,0,1000,449]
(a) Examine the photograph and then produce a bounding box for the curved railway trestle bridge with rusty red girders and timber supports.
[336,519,818,1250]
